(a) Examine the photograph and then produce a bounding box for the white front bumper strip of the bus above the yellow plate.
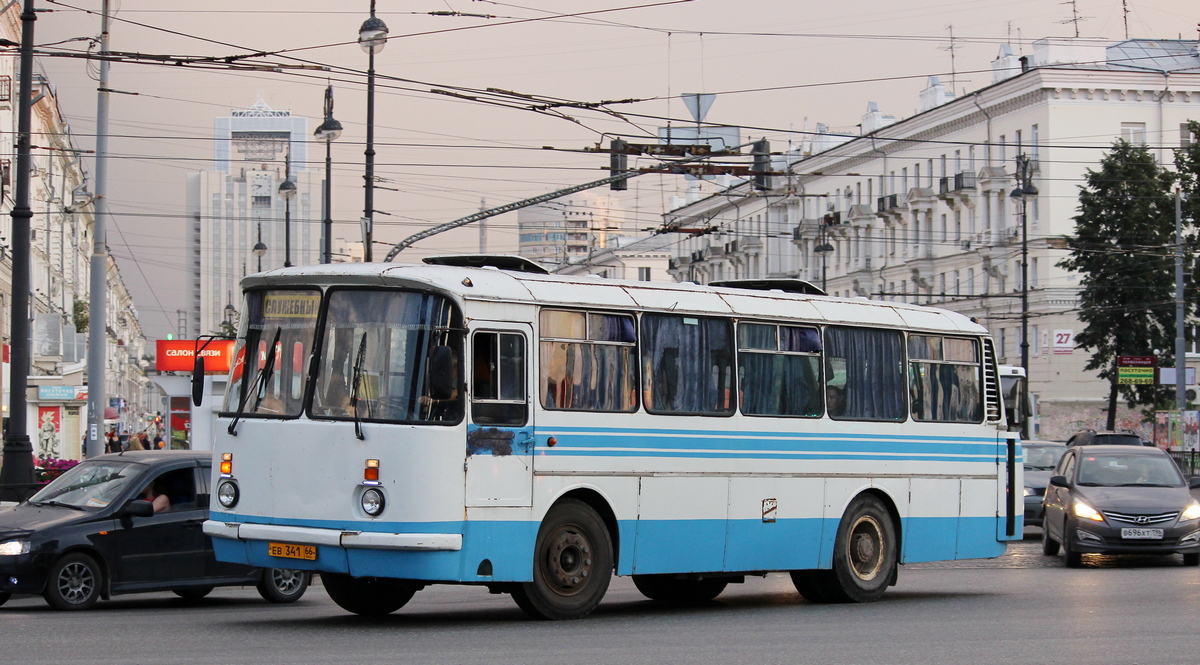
[204,520,462,552]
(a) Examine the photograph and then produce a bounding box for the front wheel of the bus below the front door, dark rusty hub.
[512,498,613,621]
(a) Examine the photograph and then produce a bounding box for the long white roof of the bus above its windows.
[242,263,986,334]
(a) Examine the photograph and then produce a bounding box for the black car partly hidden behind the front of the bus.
[0,451,311,610]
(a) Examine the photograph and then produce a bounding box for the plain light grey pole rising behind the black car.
[85,0,109,457]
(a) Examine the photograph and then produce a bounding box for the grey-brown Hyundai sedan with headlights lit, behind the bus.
[1042,445,1200,568]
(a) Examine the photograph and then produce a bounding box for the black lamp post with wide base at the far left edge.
[0,0,37,492]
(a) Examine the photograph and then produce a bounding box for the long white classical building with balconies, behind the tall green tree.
[665,40,1200,439]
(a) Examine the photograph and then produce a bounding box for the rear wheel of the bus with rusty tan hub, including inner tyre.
[792,495,899,603]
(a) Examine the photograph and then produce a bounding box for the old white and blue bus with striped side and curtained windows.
[204,257,1022,619]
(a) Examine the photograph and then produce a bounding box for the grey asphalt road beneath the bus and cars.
[0,529,1200,665]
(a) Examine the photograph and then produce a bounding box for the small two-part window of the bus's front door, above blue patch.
[470,333,529,427]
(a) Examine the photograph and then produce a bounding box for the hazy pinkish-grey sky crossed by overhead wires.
[36,0,1200,340]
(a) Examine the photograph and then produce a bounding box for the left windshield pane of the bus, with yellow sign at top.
[222,289,320,418]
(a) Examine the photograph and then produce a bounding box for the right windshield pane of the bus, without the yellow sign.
[311,289,462,424]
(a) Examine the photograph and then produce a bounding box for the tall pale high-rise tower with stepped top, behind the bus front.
[185,100,324,336]
